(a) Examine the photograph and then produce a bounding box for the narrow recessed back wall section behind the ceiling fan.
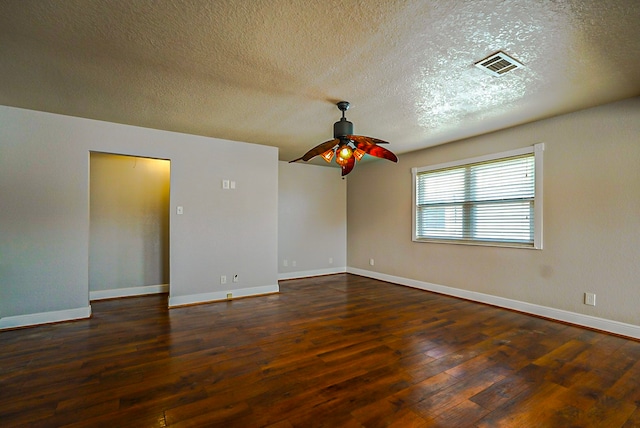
[278,162,347,279]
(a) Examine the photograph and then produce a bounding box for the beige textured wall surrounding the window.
[347,97,640,325]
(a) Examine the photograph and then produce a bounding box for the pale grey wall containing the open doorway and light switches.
[0,107,278,328]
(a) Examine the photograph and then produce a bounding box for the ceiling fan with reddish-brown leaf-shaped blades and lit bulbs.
[289,101,398,177]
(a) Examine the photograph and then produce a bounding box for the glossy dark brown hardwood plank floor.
[0,274,640,428]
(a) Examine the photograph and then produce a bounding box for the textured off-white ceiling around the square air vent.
[0,0,640,160]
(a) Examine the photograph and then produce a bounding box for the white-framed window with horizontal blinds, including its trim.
[412,143,544,248]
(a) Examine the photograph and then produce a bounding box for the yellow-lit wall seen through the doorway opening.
[89,152,171,291]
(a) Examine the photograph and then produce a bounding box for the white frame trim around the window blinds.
[411,143,544,250]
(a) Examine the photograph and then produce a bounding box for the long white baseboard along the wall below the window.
[347,267,640,339]
